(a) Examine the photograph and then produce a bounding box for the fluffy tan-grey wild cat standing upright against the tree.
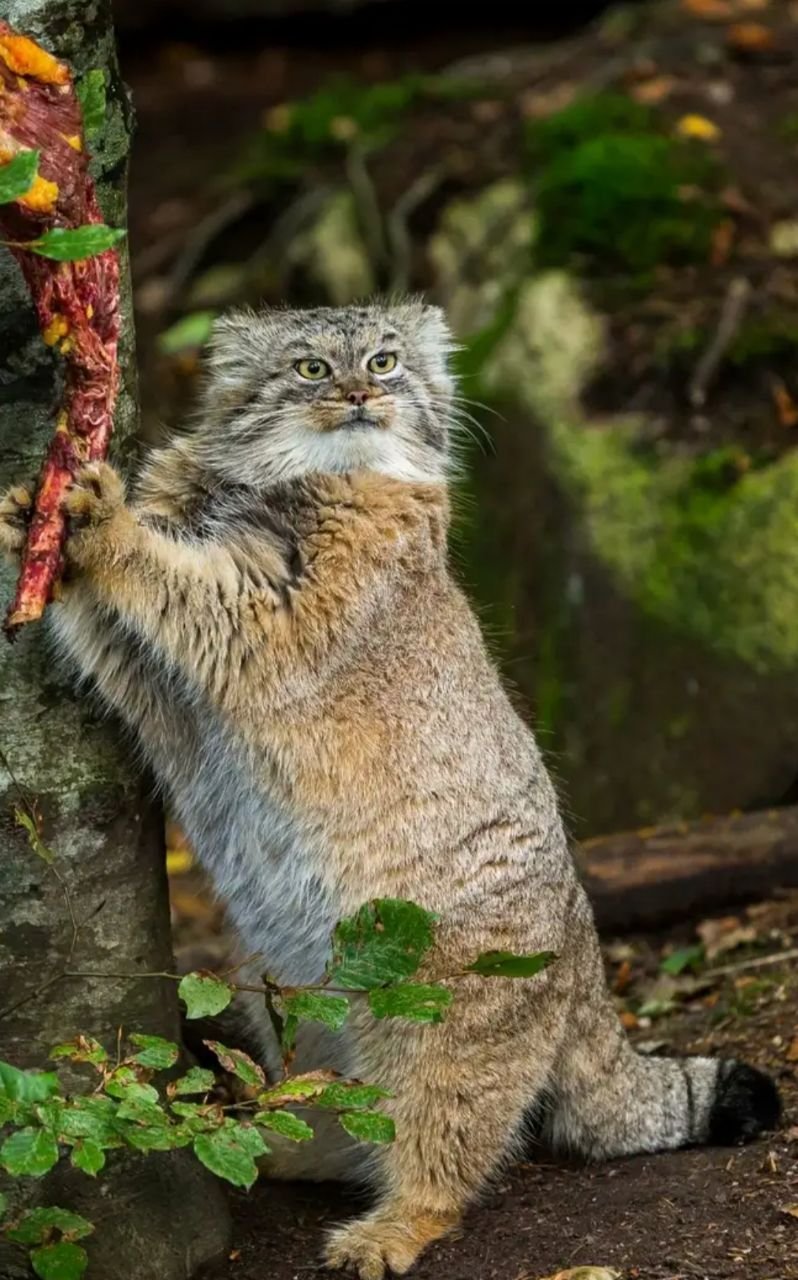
[0,301,779,1280]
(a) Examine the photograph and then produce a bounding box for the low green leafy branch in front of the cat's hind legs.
[0,899,555,1280]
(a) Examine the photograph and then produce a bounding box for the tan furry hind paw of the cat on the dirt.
[324,1210,455,1280]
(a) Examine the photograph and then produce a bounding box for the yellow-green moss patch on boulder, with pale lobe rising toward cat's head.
[483,273,798,672]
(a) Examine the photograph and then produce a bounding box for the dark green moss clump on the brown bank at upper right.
[528,95,720,274]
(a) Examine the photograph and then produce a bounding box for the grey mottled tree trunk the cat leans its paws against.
[0,0,228,1280]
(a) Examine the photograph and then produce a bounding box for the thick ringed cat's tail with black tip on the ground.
[542,977,781,1160]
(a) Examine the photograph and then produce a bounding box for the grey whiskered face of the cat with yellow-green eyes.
[194,302,452,484]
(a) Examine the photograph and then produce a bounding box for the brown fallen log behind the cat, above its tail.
[576,805,798,933]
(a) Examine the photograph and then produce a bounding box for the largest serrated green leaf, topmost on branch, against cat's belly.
[327,897,436,991]
